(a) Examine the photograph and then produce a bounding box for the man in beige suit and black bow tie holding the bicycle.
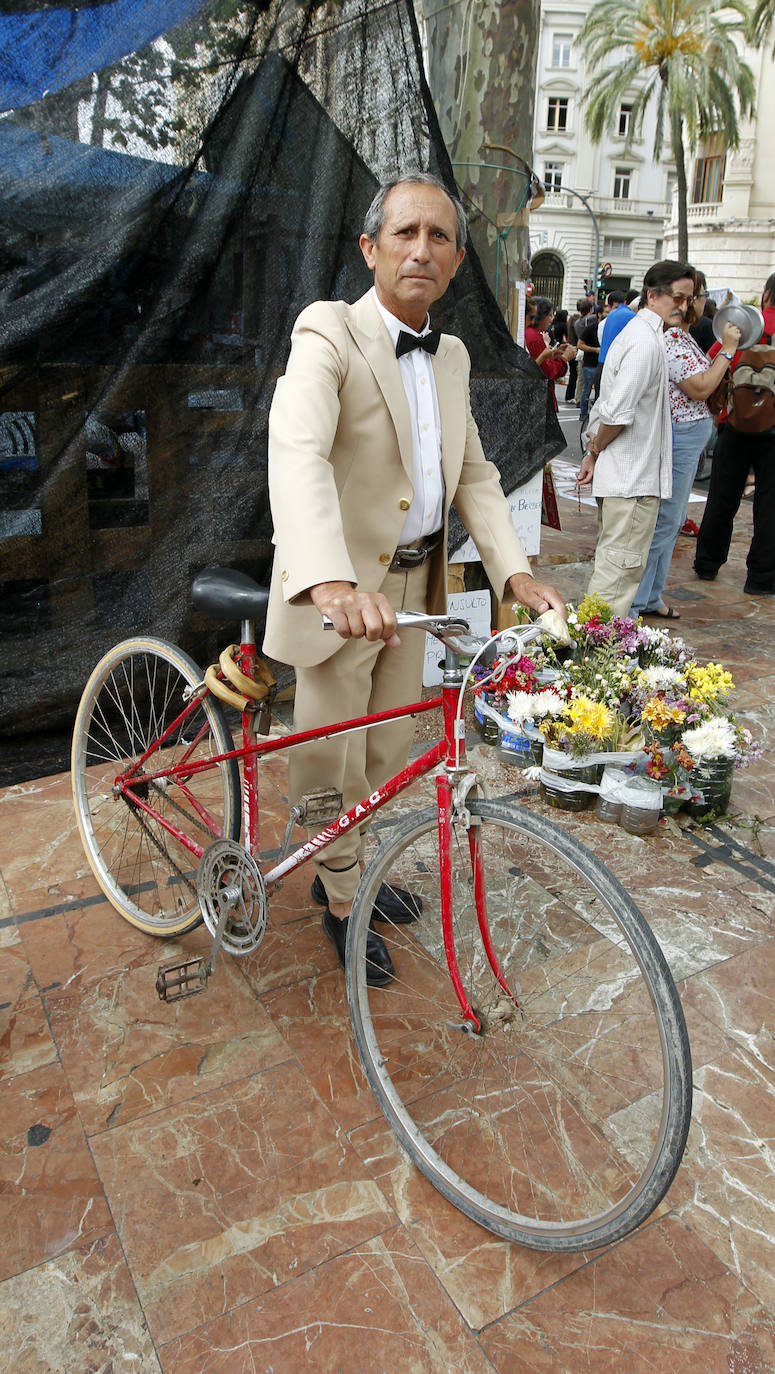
[264,173,565,985]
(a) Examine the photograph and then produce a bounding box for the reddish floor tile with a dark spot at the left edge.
[0,1063,113,1279]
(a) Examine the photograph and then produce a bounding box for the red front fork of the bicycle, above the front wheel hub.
[436,774,521,1036]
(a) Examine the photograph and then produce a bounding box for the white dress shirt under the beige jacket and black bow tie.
[372,287,444,544]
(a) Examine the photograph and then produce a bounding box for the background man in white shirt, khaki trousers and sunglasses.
[579,260,694,616]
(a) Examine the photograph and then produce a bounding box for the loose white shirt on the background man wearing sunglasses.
[589,306,673,497]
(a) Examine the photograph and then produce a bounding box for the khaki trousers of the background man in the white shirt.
[587,496,660,616]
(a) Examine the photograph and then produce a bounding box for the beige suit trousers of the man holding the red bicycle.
[289,562,428,903]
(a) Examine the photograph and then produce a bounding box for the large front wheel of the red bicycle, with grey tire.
[348,801,691,1250]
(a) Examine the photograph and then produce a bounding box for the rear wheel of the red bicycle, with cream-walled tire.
[71,638,240,937]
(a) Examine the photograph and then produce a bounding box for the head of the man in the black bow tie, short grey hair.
[360,181,466,331]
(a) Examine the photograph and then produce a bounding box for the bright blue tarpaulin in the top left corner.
[0,0,206,111]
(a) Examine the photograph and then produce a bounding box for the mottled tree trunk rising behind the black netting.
[415,0,540,313]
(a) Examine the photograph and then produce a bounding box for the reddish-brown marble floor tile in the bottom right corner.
[480,1217,775,1374]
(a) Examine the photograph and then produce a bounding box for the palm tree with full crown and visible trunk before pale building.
[580,0,753,261]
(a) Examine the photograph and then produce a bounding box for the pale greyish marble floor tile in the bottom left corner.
[0,1235,161,1374]
